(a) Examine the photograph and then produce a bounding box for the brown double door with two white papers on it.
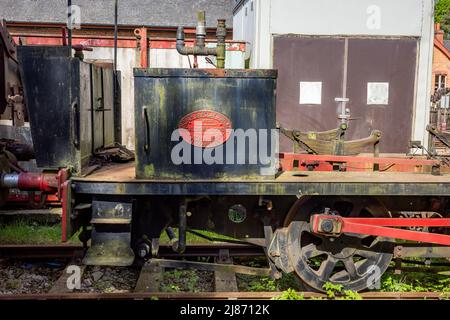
[274,35,417,152]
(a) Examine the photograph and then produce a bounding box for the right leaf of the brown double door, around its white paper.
[347,39,416,152]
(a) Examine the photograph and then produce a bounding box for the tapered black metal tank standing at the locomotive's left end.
[18,46,118,174]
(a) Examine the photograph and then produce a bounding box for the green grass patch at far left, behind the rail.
[0,219,79,244]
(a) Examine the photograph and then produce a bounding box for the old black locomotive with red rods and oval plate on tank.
[2,11,450,290]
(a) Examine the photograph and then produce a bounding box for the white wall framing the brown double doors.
[233,0,434,150]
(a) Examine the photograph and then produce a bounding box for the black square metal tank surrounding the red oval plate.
[134,69,276,180]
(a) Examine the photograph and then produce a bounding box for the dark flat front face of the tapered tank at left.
[17,46,76,171]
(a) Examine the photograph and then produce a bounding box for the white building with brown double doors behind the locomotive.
[233,0,434,152]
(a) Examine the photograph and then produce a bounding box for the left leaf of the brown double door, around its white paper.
[274,35,345,152]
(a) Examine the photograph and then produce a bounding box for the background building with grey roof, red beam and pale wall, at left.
[0,0,245,149]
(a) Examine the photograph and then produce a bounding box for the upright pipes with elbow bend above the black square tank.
[176,11,227,69]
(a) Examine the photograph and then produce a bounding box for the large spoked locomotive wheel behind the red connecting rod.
[286,198,392,291]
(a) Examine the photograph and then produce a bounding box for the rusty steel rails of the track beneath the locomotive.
[0,243,450,300]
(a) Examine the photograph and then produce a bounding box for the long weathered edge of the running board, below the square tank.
[74,174,450,197]
